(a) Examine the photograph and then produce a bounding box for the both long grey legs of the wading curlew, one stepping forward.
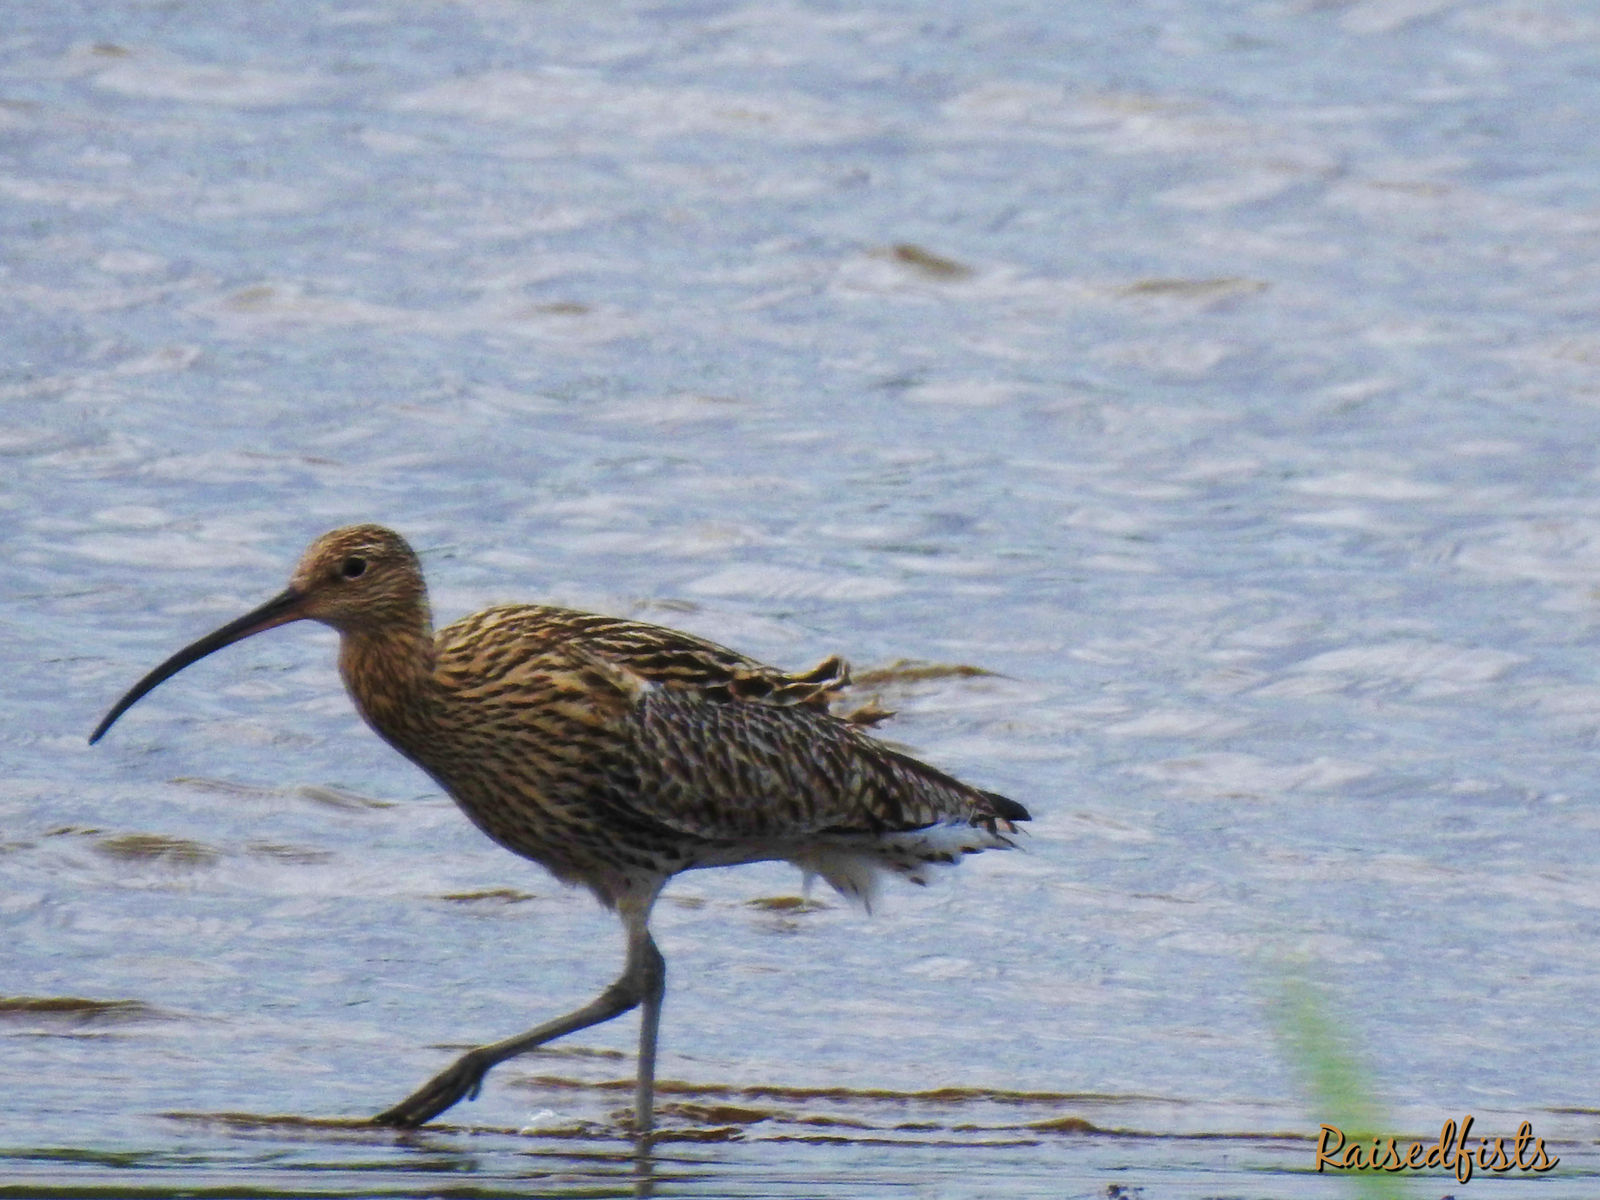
[373,896,666,1133]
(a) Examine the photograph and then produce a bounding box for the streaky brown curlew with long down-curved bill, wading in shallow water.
[90,525,1027,1136]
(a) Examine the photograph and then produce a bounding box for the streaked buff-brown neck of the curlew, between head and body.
[339,621,437,757]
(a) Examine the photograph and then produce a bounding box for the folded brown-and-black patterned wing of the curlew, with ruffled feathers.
[438,606,1027,842]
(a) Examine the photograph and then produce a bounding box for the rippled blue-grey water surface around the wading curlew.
[9,0,1600,1198]
